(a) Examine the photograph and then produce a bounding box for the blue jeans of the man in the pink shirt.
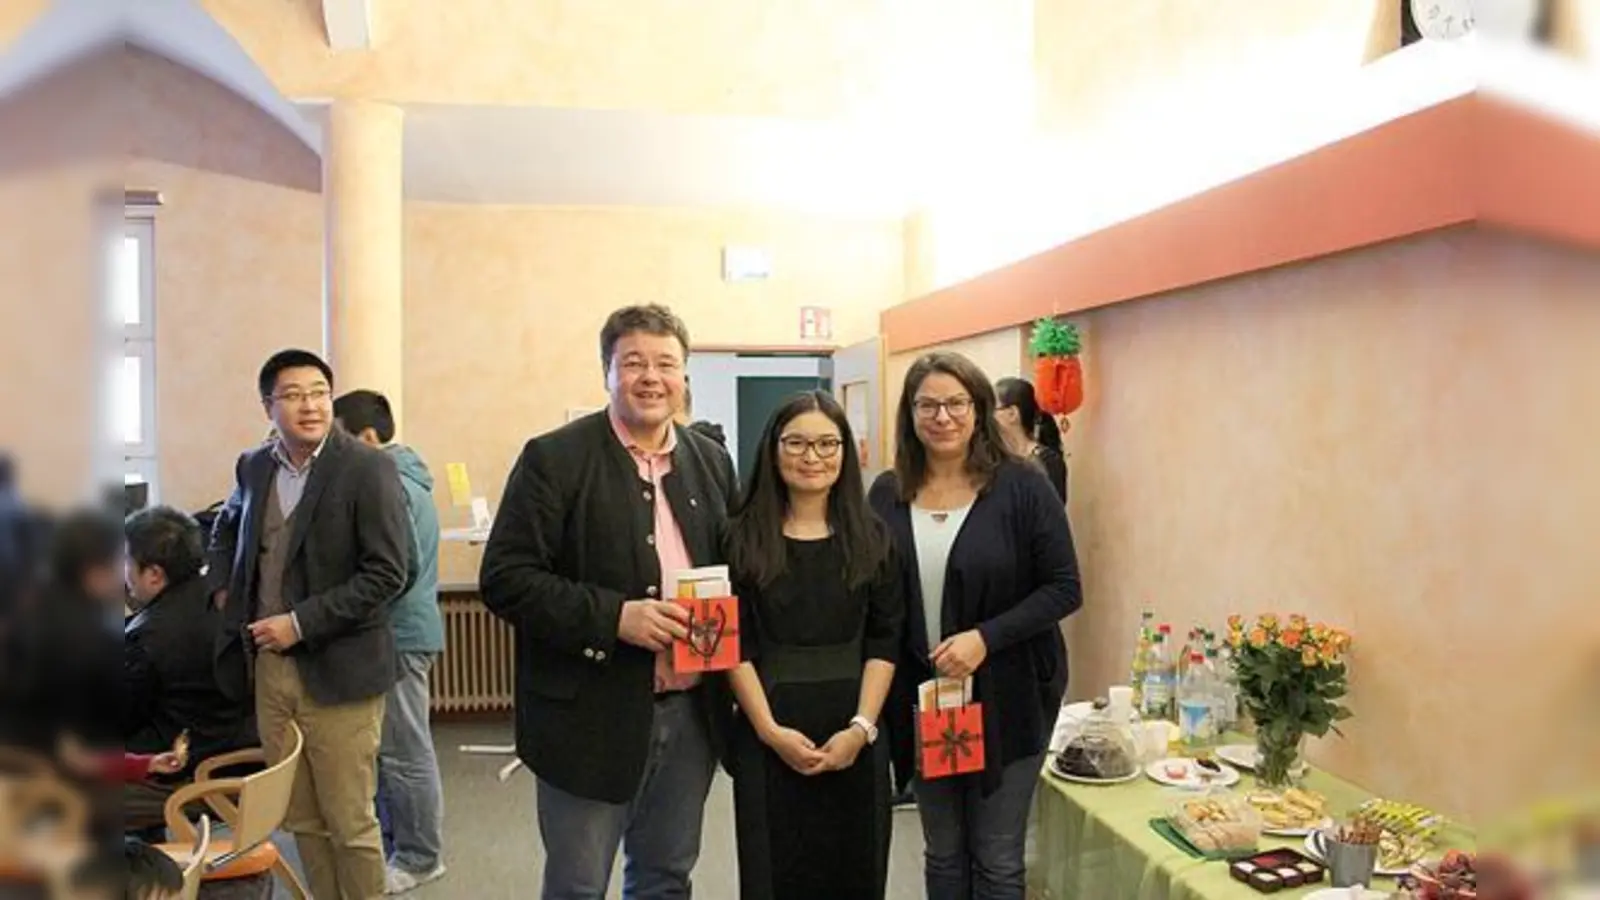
[538,693,717,900]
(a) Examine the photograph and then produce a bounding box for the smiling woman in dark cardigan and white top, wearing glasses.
[870,352,1083,900]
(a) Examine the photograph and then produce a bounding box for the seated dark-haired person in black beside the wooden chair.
[122,506,258,830]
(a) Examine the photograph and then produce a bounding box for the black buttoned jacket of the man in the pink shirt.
[478,412,734,804]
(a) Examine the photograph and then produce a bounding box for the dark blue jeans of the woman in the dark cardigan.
[917,756,1043,900]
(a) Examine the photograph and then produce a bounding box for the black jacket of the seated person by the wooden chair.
[122,578,259,772]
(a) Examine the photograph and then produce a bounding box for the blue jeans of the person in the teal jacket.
[378,653,445,874]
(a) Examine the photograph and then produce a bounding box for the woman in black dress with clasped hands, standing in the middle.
[728,391,906,900]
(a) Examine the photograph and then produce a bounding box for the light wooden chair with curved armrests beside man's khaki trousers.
[162,722,309,900]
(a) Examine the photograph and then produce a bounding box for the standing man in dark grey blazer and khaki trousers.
[206,351,411,900]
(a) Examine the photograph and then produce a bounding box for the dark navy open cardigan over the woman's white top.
[869,460,1083,793]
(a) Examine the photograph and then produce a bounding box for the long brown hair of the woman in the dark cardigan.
[894,351,1011,503]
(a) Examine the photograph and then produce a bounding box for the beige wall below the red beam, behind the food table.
[902,232,1600,820]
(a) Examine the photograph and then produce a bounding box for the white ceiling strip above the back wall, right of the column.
[301,102,917,216]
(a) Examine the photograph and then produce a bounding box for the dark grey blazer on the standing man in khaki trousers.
[206,429,411,705]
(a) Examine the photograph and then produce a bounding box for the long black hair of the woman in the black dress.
[728,391,890,588]
